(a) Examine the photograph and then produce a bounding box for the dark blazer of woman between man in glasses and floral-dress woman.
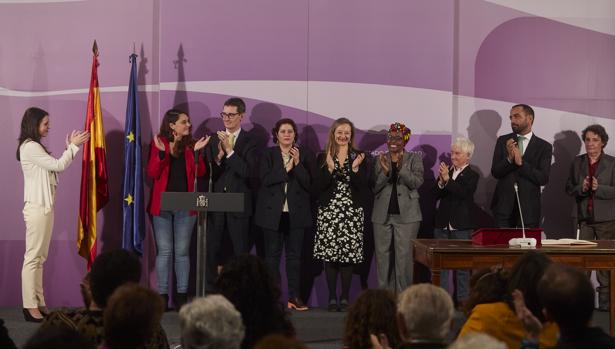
[254,145,314,230]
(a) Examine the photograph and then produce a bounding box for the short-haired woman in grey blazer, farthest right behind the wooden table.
[566,125,615,311]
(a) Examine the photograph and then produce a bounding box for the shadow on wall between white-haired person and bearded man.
[467,110,502,227]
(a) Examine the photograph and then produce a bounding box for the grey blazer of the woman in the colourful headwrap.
[372,152,423,224]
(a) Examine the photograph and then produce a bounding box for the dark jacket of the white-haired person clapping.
[434,165,480,230]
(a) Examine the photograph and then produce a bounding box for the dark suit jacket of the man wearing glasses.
[208,129,258,217]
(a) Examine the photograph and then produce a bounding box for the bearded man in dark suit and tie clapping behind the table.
[491,104,552,227]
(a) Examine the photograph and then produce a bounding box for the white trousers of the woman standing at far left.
[21,202,53,308]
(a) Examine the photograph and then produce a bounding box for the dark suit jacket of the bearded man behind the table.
[491,133,552,226]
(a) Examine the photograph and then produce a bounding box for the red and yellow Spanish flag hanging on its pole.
[77,41,109,270]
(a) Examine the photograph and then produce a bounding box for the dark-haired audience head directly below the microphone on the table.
[506,251,551,321]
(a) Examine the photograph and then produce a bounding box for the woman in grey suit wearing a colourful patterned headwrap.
[372,122,423,293]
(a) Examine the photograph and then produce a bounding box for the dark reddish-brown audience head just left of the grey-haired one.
[103,284,164,349]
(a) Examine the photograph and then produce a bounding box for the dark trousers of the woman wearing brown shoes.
[263,212,305,298]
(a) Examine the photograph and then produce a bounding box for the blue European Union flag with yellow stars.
[122,53,145,254]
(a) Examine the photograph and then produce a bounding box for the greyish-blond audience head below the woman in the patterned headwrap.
[397,284,455,341]
